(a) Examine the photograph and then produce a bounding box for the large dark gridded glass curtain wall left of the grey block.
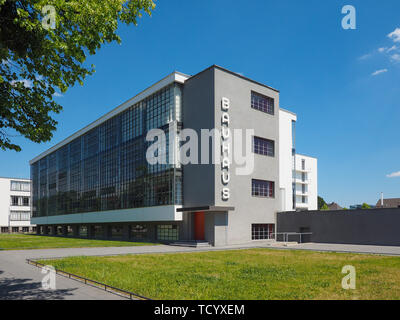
[31,83,182,217]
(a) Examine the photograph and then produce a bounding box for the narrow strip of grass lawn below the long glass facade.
[0,234,158,250]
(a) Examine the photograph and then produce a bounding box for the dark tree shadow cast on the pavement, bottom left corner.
[0,270,76,300]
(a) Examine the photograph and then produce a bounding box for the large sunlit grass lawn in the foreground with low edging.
[42,249,400,300]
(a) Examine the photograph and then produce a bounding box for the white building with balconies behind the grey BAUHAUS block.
[279,108,318,211]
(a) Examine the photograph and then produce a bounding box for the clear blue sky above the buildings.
[0,0,400,206]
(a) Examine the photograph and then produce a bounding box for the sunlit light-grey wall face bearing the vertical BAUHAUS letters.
[214,68,281,244]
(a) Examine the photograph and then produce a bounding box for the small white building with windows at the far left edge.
[0,177,36,233]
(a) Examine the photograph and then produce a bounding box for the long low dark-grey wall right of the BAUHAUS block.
[277,208,400,246]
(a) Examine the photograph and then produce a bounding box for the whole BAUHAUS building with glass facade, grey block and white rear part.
[30,65,317,246]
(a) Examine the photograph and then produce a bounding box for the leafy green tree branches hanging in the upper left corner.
[0,0,155,151]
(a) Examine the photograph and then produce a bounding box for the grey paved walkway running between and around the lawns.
[0,242,400,300]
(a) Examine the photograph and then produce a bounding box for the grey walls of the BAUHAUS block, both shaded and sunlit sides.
[183,66,280,245]
